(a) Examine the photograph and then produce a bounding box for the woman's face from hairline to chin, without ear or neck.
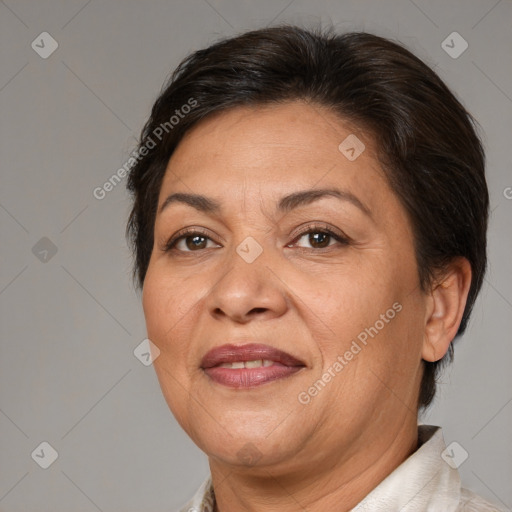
[143,102,426,474]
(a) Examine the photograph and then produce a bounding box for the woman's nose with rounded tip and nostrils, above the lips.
[207,244,288,323]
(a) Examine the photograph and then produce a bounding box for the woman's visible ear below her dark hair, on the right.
[421,257,471,362]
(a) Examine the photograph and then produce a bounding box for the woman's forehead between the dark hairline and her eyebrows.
[159,101,386,213]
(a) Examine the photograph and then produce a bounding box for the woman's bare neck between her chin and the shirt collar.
[210,419,418,512]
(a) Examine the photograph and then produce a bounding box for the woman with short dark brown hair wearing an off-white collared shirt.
[127,26,504,512]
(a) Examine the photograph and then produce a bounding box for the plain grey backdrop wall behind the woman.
[0,0,512,512]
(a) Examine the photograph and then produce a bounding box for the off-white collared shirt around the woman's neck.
[179,425,505,512]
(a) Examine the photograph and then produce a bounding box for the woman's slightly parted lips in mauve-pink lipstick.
[201,343,306,388]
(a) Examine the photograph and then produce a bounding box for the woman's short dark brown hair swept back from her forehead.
[126,25,489,408]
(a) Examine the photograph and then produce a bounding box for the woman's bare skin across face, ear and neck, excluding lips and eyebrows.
[142,101,471,512]
